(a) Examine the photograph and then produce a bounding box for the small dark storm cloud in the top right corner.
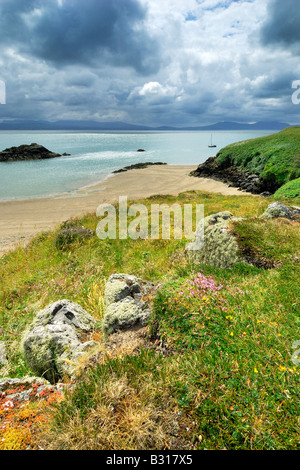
[261,0,300,54]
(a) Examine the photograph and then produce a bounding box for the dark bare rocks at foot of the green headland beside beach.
[190,157,271,196]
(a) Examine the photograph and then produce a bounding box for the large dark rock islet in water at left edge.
[0,143,68,162]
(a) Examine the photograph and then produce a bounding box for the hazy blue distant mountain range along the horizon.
[0,120,295,131]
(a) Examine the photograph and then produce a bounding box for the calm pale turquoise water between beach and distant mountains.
[0,131,275,200]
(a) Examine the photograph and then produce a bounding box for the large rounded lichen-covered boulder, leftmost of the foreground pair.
[21,299,98,383]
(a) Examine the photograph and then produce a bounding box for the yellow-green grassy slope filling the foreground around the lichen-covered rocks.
[0,192,300,449]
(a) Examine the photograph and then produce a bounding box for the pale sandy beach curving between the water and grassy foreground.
[0,165,244,256]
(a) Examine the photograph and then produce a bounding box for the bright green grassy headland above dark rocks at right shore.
[217,127,300,187]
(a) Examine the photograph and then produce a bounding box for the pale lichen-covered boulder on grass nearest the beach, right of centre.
[186,211,245,268]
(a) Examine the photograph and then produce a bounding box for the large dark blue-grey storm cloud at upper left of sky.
[0,0,160,74]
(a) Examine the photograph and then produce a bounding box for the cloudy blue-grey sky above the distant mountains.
[0,0,300,126]
